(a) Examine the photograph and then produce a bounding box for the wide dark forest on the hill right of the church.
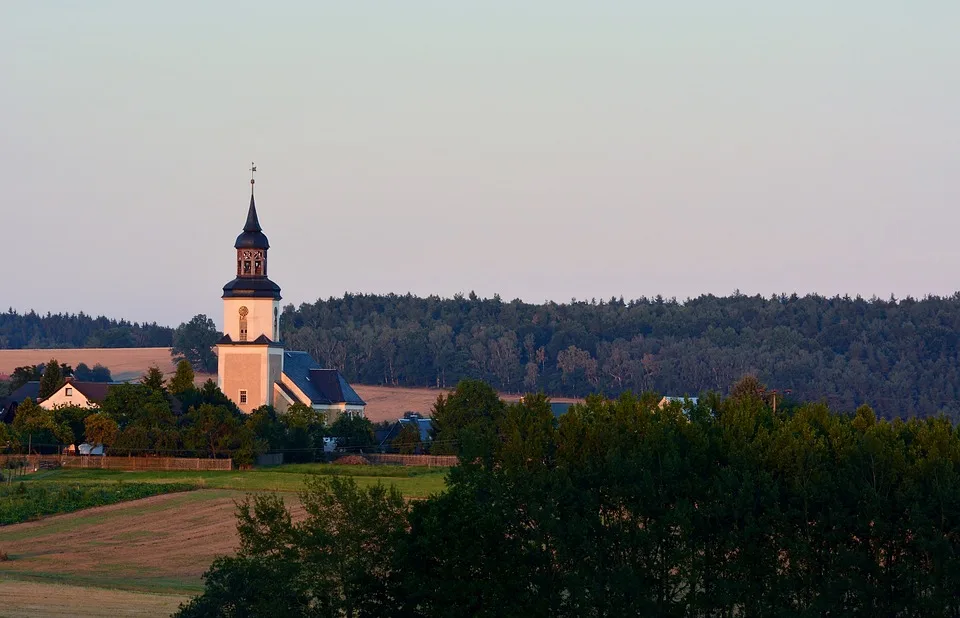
[281,293,960,419]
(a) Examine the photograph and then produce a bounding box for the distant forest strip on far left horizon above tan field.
[0,309,173,349]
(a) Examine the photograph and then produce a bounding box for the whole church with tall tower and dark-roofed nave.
[217,166,366,424]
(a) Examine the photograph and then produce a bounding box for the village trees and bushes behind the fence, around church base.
[0,360,378,464]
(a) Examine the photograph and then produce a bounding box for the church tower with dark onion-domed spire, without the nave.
[217,165,283,412]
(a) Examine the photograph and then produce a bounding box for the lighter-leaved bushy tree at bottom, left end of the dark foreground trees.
[176,476,407,618]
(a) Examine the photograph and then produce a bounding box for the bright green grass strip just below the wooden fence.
[15,464,447,498]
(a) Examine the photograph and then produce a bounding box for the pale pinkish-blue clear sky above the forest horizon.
[0,0,960,326]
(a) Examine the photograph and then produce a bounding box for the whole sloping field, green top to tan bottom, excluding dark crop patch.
[0,464,446,616]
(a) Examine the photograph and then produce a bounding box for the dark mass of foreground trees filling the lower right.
[178,379,960,618]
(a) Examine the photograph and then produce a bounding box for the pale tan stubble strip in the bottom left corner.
[0,580,189,618]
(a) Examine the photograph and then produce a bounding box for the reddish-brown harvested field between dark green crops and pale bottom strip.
[0,490,290,592]
